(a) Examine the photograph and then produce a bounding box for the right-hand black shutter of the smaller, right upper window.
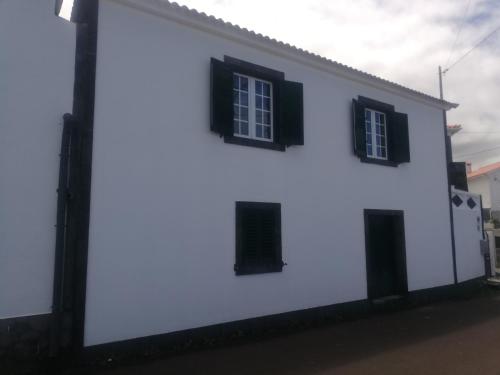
[388,112,410,163]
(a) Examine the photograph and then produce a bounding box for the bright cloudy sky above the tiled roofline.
[178,0,500,169]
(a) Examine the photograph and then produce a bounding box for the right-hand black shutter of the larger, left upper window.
[277,81,304,146]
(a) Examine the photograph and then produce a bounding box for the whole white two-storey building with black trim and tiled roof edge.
[0,0,484,358]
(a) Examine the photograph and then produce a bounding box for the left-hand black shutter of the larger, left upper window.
[210,58,233,136]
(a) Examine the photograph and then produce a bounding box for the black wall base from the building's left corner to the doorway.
[82,300,370,363]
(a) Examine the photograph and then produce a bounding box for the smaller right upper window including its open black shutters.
[352,96,410,167]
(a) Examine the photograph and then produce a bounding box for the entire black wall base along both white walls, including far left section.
[0,278,491,373]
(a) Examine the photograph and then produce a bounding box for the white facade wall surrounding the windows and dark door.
[85,1,453,345]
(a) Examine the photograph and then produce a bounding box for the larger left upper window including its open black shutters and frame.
[210,56,304,151]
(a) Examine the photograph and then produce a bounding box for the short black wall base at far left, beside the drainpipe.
[0,314,51,360]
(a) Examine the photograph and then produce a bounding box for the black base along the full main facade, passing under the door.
[80,278,488,365]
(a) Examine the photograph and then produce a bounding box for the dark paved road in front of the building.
[78,293,500,375]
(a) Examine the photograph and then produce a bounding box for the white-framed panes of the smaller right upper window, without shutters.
[365,108,387,160]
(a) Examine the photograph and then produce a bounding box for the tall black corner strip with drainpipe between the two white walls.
[50,0,98,356]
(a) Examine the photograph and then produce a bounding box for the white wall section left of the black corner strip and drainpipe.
[0,0,75,319]
